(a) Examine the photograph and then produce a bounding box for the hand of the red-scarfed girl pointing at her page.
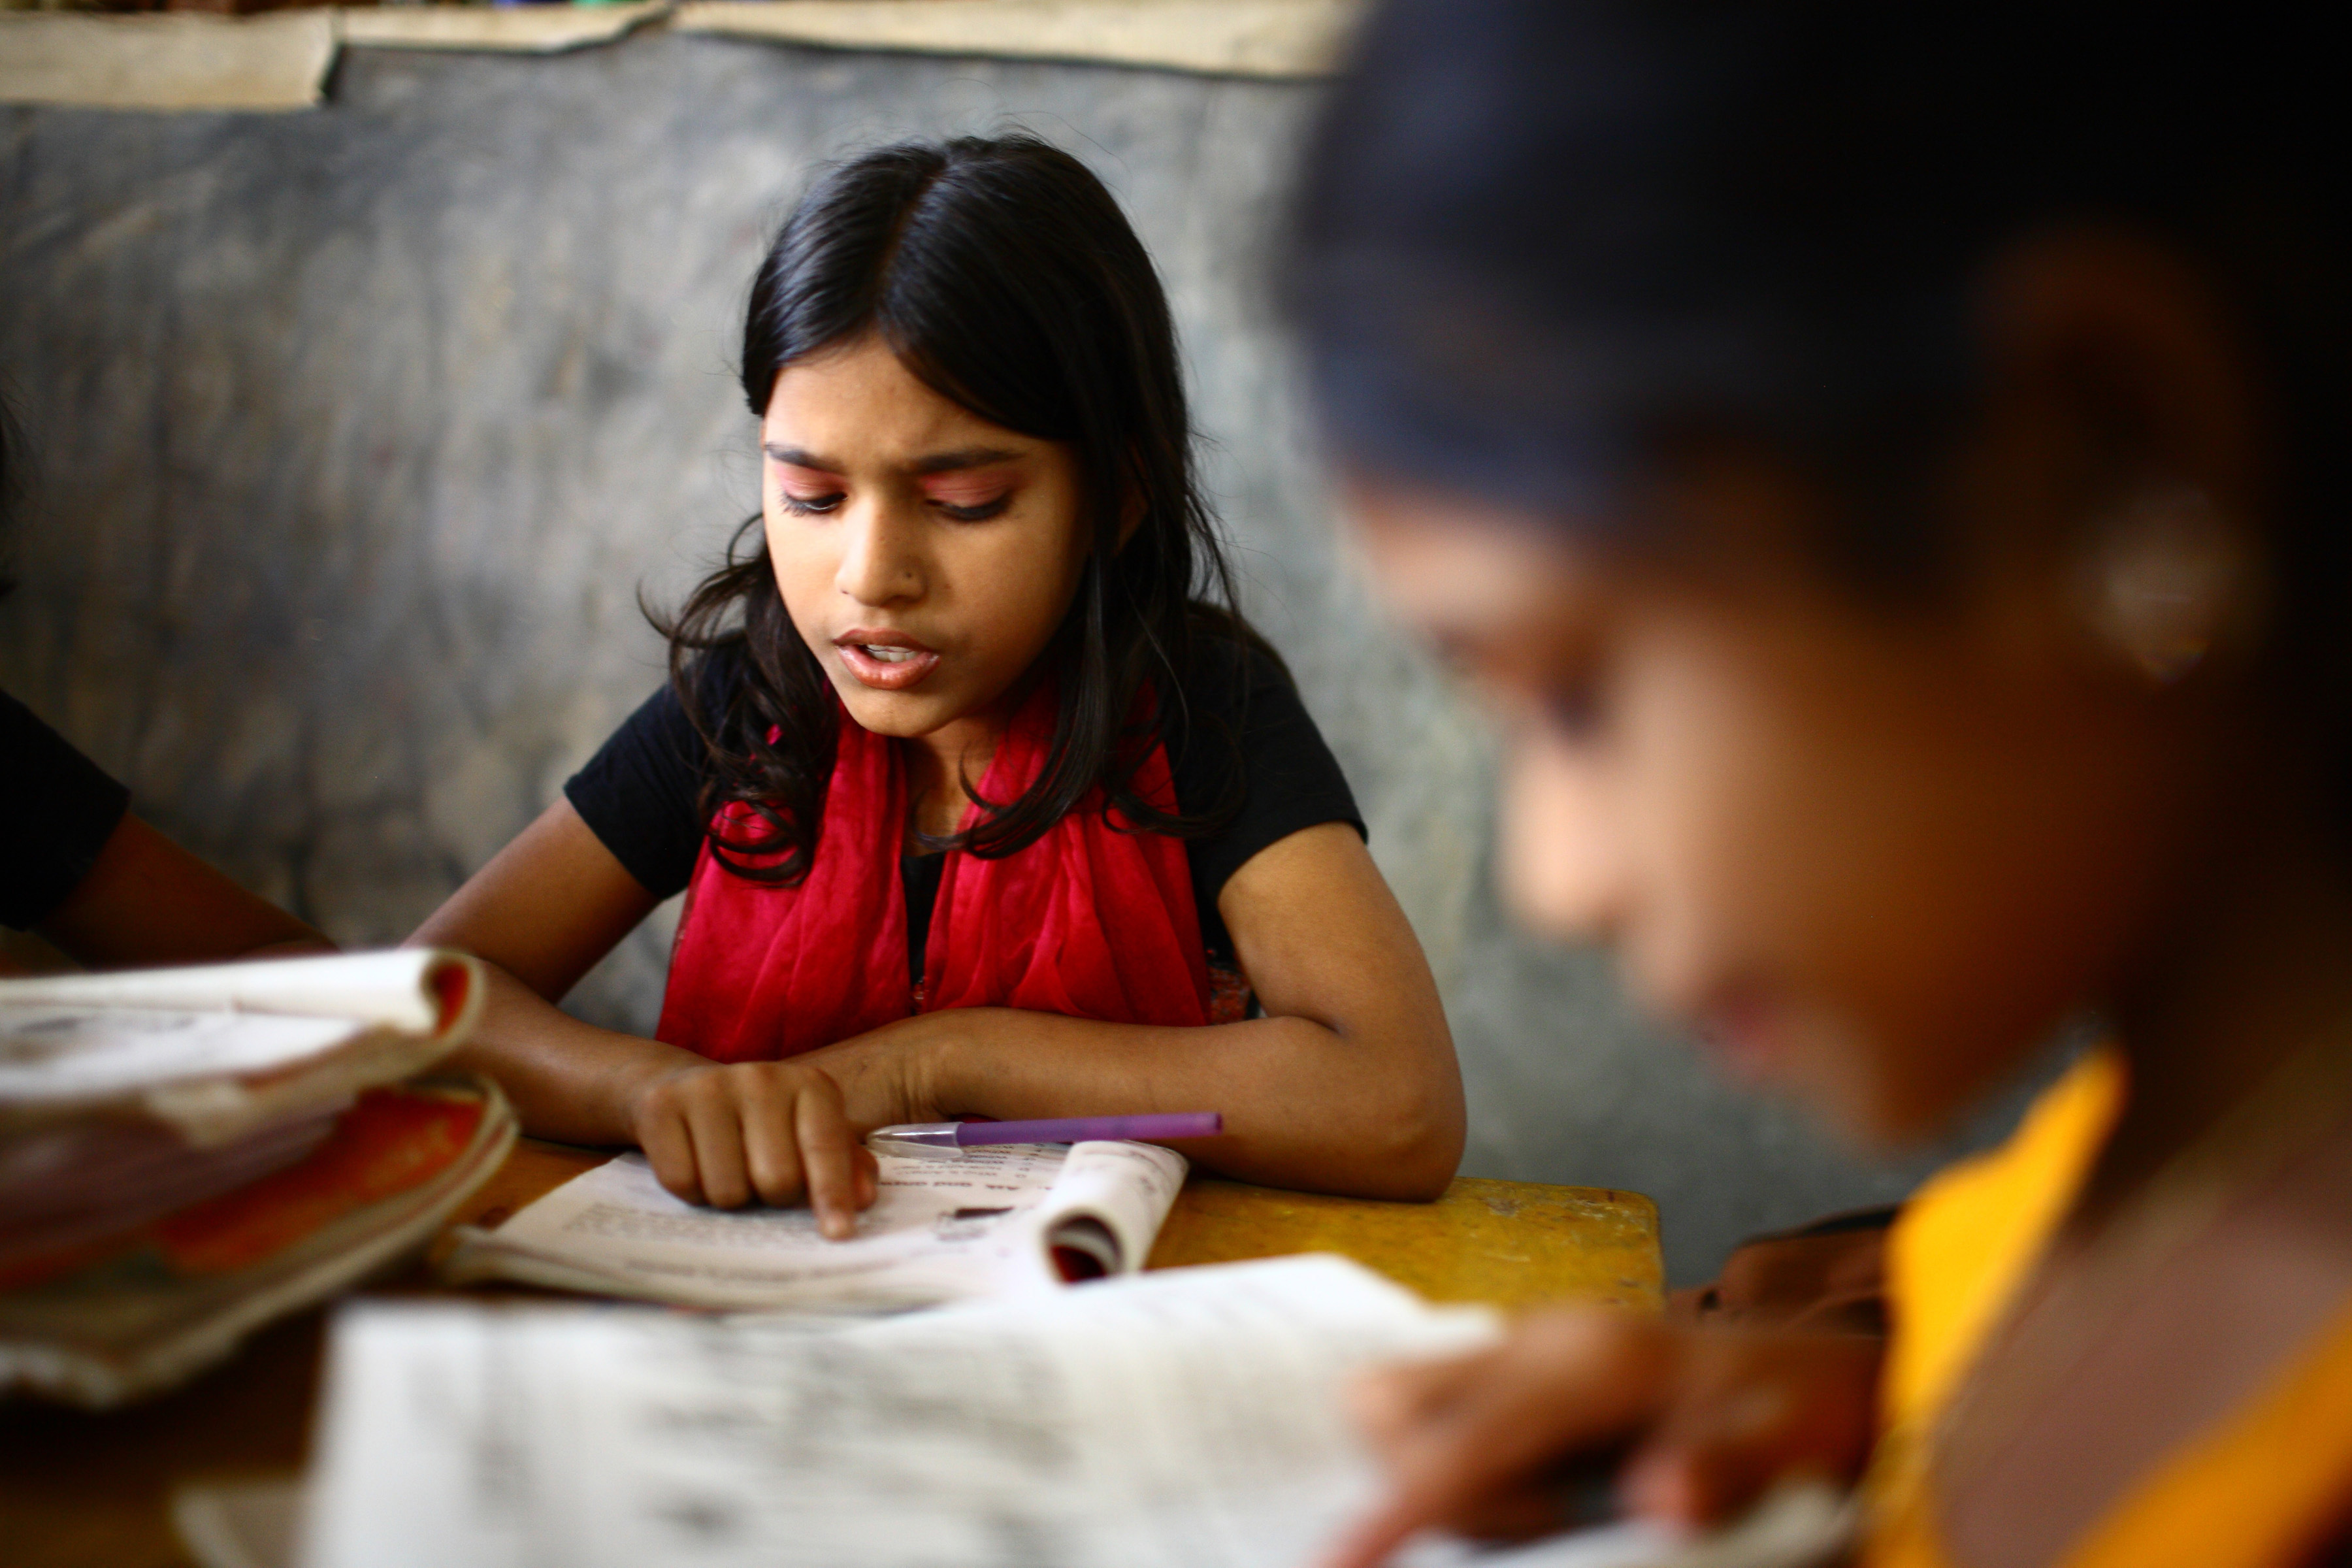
[628,1058,879,1241]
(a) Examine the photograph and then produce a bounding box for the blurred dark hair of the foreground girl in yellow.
[1286,0,2352,625]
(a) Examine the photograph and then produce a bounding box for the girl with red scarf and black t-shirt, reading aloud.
[416,137,1463,1237]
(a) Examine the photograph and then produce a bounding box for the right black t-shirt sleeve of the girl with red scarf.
[1169,644,1364,955]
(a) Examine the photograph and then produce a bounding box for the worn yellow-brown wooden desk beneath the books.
[0,1140,1665,1568]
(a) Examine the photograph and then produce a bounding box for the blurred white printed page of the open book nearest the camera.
[303,1258,1494,1568]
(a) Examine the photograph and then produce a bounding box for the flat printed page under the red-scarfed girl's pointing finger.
[447,1145,1091,1307]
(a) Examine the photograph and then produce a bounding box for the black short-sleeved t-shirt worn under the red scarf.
[564,647,1364,975]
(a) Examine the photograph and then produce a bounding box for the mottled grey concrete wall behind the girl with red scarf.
[0,35,1947,1279]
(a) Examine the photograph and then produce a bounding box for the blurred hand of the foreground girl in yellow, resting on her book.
[1326,1309,1884,1568]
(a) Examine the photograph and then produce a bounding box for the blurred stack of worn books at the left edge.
[0,952,515,1406]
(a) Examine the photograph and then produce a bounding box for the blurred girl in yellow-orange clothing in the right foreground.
[1294,0,2352,1568]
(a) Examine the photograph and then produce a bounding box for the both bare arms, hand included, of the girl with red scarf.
[412,802,1463,1213]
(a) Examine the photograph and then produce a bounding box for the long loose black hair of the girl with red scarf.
[656,137,1270,881]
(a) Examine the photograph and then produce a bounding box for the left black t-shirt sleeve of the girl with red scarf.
[564,684,703,898]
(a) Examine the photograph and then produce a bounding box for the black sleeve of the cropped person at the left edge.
[0,691,132,931]
